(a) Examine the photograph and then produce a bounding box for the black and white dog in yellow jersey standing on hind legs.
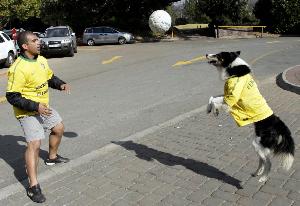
[206,51,295,182]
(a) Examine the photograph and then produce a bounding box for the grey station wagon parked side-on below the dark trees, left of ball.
[82,26,134,46]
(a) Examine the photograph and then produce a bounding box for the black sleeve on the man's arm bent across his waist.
[6,92,39,112]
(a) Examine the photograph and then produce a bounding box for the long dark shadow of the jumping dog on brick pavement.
[112,141,242,189]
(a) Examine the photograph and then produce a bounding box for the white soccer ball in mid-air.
[149,10,172,34]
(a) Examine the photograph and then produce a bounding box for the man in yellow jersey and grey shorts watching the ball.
[6,31,70,203]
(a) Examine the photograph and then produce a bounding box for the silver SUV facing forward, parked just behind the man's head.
[41,26,77,56]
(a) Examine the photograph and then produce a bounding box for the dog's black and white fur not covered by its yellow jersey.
[206,51,295,182]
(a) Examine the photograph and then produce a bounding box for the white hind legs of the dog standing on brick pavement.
[252,137,271,182]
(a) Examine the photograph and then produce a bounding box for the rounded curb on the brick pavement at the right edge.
[276,65,300,95]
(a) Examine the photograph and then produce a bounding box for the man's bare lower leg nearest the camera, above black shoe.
[25,140,41,187]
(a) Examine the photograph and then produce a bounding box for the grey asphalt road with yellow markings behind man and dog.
[0,37,300,188]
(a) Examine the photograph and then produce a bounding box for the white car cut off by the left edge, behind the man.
[0,31,17,67]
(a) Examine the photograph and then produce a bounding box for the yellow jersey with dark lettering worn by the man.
[7,56,53,118]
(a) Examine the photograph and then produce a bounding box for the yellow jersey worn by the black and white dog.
[224,74,273,126]
